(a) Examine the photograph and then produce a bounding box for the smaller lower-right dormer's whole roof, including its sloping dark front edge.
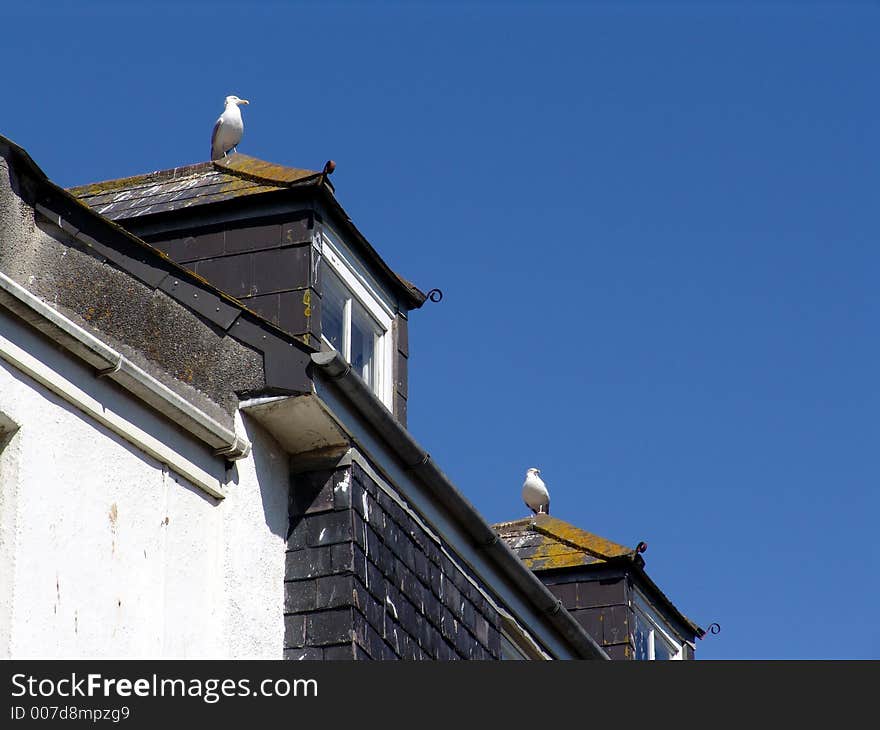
[492,514,706,638]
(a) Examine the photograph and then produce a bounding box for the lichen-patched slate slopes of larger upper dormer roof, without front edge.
[69,152,325,220]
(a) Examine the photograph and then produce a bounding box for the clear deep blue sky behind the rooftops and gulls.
[0,0,880,659]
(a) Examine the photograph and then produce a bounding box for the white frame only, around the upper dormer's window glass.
[320,226,394,411]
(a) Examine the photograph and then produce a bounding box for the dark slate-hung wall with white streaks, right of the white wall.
[284,464,501,659]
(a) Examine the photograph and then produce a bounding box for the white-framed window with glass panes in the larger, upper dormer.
[321,229,394,410]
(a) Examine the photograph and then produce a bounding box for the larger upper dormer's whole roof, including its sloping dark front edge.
[68,152,426,309]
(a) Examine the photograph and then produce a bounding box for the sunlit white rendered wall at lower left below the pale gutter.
[0,309,288,659]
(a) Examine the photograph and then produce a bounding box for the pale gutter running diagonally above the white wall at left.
[0,272,251,461]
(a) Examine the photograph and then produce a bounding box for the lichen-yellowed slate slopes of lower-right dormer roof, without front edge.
[494,514,637,571]
